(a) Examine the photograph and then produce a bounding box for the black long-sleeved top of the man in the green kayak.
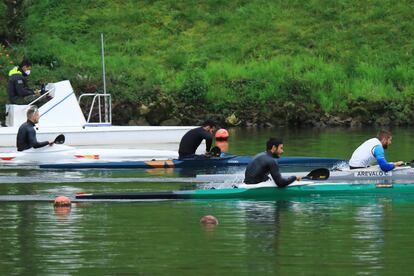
[244,151,296,187]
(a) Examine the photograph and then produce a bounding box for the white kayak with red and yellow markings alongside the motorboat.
[0,144,178,166]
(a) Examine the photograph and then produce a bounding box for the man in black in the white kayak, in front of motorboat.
[16,106,54,151]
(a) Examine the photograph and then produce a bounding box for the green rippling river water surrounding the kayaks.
[0,128,414,275]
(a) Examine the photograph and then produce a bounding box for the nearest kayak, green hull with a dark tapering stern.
[76,183,414,200]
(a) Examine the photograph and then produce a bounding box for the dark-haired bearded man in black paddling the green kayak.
[244,138,301,187]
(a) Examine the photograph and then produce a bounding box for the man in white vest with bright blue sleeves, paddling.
[349,130,404,172]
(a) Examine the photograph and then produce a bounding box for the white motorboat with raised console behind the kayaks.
[0,80,194,149]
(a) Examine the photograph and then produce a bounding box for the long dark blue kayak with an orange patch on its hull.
[40,155,344,169]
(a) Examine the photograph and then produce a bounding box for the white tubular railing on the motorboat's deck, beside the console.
[78,93,112,126]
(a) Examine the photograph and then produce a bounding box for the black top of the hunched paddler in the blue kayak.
[178,127,213,159]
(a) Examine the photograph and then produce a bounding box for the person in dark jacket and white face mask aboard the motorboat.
[7,59,40,104]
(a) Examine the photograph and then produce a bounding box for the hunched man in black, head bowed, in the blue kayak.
[178,120,216,159]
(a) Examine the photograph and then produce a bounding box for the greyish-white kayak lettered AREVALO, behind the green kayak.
[196,165,414,184]
